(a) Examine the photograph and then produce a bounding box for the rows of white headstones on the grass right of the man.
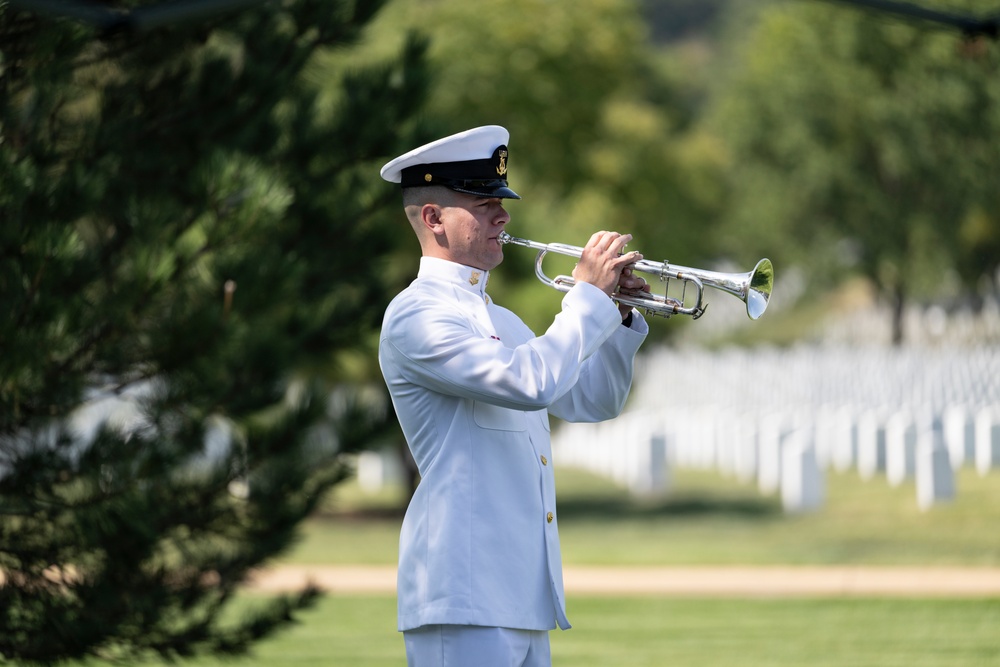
[553,347,1000,512]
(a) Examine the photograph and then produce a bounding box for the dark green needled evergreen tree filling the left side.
[0,0,426,664]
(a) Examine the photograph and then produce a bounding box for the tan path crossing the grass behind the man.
[252,565,1000,597]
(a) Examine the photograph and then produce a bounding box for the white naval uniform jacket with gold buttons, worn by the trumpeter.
[379,257,648,631]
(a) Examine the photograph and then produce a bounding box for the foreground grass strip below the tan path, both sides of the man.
[125,596,1000,667]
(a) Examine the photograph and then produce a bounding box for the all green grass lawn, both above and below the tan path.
[80,469,1000,667]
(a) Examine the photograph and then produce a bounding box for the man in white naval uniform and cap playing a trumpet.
[379,126,648,667]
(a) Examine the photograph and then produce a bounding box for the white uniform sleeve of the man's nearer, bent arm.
[379,283,623,410]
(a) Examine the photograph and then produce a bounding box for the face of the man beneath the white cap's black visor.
[441,192,510,271]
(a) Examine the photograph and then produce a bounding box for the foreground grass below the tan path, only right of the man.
[551,598,1000,667]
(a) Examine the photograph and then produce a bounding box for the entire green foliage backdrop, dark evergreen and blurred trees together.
[0,0,1000,662]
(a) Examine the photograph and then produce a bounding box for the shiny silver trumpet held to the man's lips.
[497,232,774,320]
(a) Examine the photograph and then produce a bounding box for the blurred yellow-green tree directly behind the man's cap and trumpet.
[342,0,719,336]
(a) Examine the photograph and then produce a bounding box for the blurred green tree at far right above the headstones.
[713,3,1000,343]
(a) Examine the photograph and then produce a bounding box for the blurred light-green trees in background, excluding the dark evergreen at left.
[312,0,1000,342]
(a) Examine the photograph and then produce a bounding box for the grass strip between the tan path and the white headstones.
[285,469,1000,567]
